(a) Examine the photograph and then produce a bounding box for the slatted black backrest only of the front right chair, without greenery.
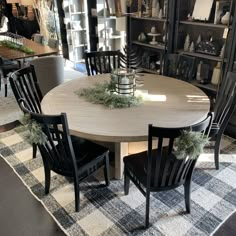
[147,115,213,190]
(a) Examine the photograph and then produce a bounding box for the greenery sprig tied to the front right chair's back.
[174,130,209,159]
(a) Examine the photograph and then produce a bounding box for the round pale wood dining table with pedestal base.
[41,74,210,179]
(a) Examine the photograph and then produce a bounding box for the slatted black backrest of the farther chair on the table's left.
[9,65,43,113]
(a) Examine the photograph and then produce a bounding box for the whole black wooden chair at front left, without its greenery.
[20,99,110,211]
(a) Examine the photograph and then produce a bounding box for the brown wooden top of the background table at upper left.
[0,38,58,60]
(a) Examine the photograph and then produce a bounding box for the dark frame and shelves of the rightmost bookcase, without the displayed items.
[173,0,235,94]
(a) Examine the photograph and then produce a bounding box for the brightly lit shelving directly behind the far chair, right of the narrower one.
[87,0,126,51]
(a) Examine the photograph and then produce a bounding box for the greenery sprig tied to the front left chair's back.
[17,114,47,145]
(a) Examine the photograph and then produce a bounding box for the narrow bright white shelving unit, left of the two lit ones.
[63,0,88,67]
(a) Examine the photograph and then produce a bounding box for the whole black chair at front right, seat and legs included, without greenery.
[124,113,213,227]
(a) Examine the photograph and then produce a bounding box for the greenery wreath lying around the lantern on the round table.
[75,82,143,109]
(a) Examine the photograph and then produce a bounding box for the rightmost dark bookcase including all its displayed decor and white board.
[174,0,235,95]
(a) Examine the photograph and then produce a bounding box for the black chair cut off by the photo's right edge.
[210,72,236,170]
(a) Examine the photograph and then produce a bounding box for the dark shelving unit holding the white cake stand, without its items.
[130,0,175,74]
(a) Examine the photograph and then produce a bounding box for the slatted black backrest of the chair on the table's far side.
[85,51,122,76]
